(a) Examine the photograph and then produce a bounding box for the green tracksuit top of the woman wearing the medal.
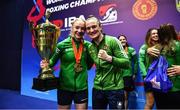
[50,36,92,92]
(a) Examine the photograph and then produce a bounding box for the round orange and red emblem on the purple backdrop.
[132,0,158,20]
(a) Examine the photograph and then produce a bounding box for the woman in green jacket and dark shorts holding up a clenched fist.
[86,16,130,109]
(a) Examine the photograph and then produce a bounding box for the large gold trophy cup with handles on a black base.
[30,11,60,91]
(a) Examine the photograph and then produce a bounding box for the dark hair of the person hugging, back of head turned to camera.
[158,23,177,45]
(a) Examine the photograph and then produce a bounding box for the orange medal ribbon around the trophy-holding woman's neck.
[72,38,83,63]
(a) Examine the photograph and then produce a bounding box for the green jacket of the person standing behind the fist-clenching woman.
[123,47,138,77]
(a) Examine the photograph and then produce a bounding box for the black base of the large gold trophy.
[32,77,58,91]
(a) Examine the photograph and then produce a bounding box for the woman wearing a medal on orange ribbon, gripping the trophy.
[40,18,92,109]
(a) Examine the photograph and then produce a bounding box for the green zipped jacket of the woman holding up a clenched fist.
[88,35,130,90]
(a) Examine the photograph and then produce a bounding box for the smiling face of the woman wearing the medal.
[71,19,85,39]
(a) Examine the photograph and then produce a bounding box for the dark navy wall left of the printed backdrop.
[0,0,24,90]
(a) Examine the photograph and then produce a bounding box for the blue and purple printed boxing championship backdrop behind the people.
[21,0,180,108]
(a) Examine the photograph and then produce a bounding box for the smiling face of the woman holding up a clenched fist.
[86,17,102,39]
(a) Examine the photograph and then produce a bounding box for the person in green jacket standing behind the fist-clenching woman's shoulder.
[118,35,138,110]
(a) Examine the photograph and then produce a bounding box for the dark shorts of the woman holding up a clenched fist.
[92,89,124,109]
